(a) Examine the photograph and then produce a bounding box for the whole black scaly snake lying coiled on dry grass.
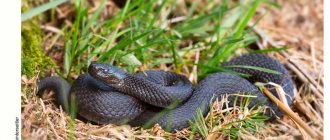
[37,53,294,132]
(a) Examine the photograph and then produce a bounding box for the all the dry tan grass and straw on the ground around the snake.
[21,0,324,139]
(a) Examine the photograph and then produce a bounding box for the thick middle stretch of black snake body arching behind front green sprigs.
[134,73,270,131]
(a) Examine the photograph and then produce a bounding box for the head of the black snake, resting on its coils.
[88,62,126,86]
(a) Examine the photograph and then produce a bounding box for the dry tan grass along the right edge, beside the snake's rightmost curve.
[254,0,324,139]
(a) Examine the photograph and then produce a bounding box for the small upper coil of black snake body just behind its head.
[116,70,192,107]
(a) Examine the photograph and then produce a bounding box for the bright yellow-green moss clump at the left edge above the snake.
[21,21,55,77]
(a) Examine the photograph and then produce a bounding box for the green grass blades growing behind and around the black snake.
[22,0,285,138]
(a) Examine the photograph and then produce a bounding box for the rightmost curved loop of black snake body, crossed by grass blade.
[223,54,294,117]
